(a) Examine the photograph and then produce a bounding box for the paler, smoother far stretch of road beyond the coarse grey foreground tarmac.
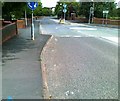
[41,18,118,43]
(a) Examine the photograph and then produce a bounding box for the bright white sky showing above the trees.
[41,0,120,7]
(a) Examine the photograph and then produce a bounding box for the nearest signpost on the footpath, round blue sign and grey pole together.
[27,2,38,40]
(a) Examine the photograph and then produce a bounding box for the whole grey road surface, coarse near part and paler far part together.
[40,18,118,99]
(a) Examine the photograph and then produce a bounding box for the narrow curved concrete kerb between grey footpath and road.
[40,35,53,99]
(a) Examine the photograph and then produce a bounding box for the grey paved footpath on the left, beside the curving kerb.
[2,21,50,99]
